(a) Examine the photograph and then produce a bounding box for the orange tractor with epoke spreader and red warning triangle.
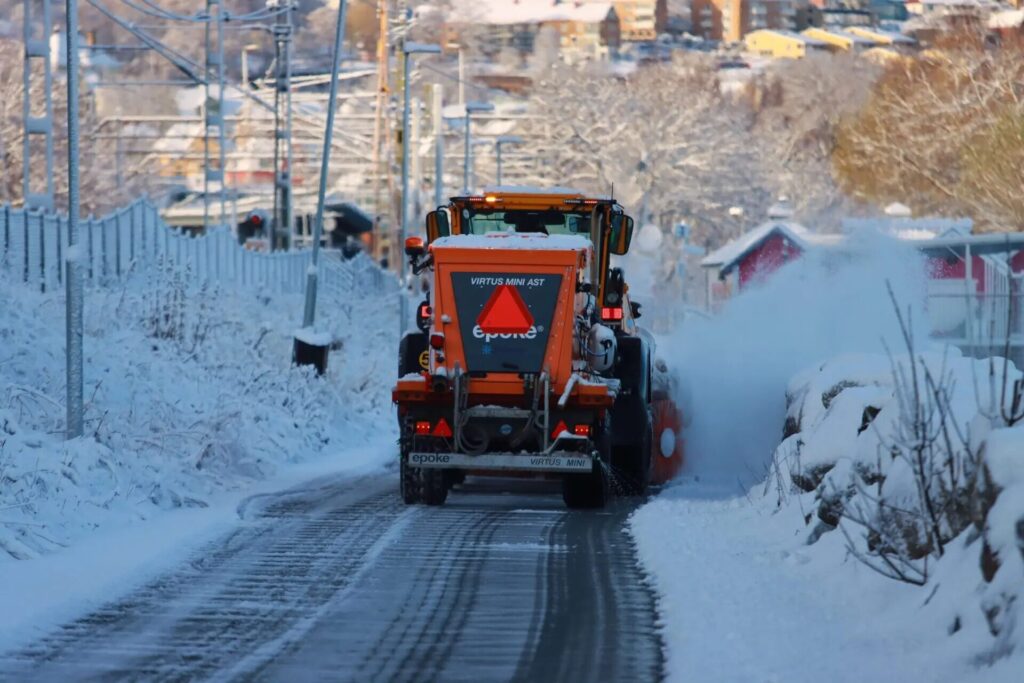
[392,188,682,508]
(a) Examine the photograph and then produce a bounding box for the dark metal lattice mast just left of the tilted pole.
[267,0,294,251]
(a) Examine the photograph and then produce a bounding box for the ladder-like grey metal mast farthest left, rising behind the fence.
[22,0,53,211]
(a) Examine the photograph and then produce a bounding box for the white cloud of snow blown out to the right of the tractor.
[663,234,927,490]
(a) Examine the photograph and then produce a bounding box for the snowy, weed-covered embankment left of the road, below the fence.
[0,262,397,561]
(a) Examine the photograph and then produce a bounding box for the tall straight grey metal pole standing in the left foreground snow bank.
[64,0,85,439]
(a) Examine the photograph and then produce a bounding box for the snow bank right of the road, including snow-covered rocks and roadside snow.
[631,350,1024,683]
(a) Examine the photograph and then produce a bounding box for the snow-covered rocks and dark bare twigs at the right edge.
[774,342,1024,661]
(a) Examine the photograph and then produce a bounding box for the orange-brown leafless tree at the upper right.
[836,44,1024,229]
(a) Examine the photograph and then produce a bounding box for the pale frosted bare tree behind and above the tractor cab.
[512,57,770,238]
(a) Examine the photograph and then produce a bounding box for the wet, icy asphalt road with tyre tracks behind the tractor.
[0,474,664,682]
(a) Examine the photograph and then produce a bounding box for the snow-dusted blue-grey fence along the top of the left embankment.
[0,199,398,302]
